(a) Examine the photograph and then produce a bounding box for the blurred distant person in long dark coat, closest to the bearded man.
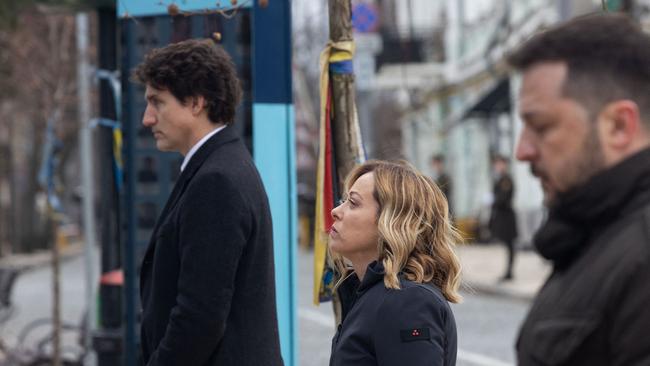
[489,156,517,281]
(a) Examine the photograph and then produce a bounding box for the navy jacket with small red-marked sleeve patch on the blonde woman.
[330,262,457,366]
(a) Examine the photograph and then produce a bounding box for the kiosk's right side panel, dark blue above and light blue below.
[251,0,298,366]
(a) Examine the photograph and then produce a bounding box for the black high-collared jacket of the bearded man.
[517,150,650,366]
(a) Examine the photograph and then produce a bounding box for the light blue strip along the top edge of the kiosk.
[117,0,249,18]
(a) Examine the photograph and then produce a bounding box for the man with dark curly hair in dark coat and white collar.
[134,40,282,366]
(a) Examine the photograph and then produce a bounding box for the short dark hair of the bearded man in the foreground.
[508,13,650,122]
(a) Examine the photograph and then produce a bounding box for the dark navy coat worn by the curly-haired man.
[140,127,282,366]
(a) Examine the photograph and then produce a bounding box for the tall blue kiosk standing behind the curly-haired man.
[117,0,298,366]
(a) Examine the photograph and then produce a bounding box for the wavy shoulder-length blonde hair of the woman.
[330,160,462,303]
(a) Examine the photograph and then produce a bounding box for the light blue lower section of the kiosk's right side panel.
[253,104,298,366]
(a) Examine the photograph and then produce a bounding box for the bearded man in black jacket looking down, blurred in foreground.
[509,13,650,366]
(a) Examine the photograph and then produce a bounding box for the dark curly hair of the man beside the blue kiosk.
[133,39,242,124]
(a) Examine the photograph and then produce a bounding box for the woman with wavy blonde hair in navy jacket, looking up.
[329,161,461,366]
